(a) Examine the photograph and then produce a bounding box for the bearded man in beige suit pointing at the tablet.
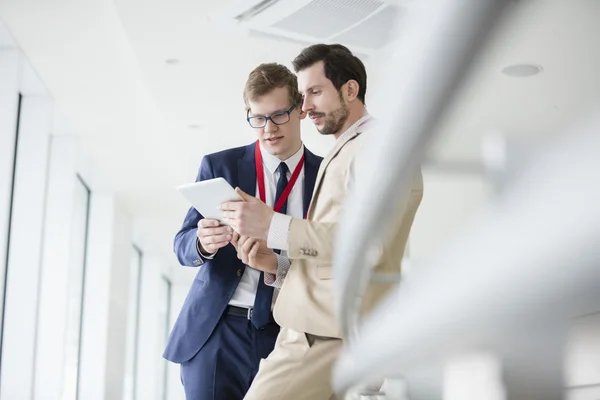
[222,44,423,400]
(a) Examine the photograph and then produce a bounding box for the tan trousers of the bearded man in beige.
[244,328,342,400]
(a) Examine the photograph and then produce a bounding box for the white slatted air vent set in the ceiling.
[211,0,414,54]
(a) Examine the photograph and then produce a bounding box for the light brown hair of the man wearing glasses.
[244,63,302,110]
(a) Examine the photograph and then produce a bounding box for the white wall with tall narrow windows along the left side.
[0,26,170,400]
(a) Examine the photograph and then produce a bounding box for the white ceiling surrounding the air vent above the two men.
[0,0,600,270]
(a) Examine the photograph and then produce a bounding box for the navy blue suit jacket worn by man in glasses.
[163,144,322,363]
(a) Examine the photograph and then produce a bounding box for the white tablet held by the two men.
[177,178,242,225]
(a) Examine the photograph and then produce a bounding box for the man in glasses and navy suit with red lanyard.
[164,63,322,400]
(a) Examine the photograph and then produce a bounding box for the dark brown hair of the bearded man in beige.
[292,44,367,104]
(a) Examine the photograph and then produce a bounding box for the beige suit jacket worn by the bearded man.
[274,124,423,338]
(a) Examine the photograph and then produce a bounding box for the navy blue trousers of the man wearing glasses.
[181,314,279,400]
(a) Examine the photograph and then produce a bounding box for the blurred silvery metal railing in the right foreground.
[334,0,600,399]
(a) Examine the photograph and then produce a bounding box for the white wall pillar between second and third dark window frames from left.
[79,193,131,400]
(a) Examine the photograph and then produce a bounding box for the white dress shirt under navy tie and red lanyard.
[229,146,304,307]
